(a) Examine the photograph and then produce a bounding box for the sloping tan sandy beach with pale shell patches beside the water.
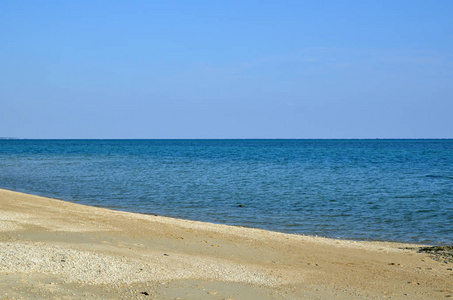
[0,190,453,300]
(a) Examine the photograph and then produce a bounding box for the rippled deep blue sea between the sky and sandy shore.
[0,140,453,244]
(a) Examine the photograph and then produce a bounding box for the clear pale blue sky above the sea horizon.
[0,0,453,139]
